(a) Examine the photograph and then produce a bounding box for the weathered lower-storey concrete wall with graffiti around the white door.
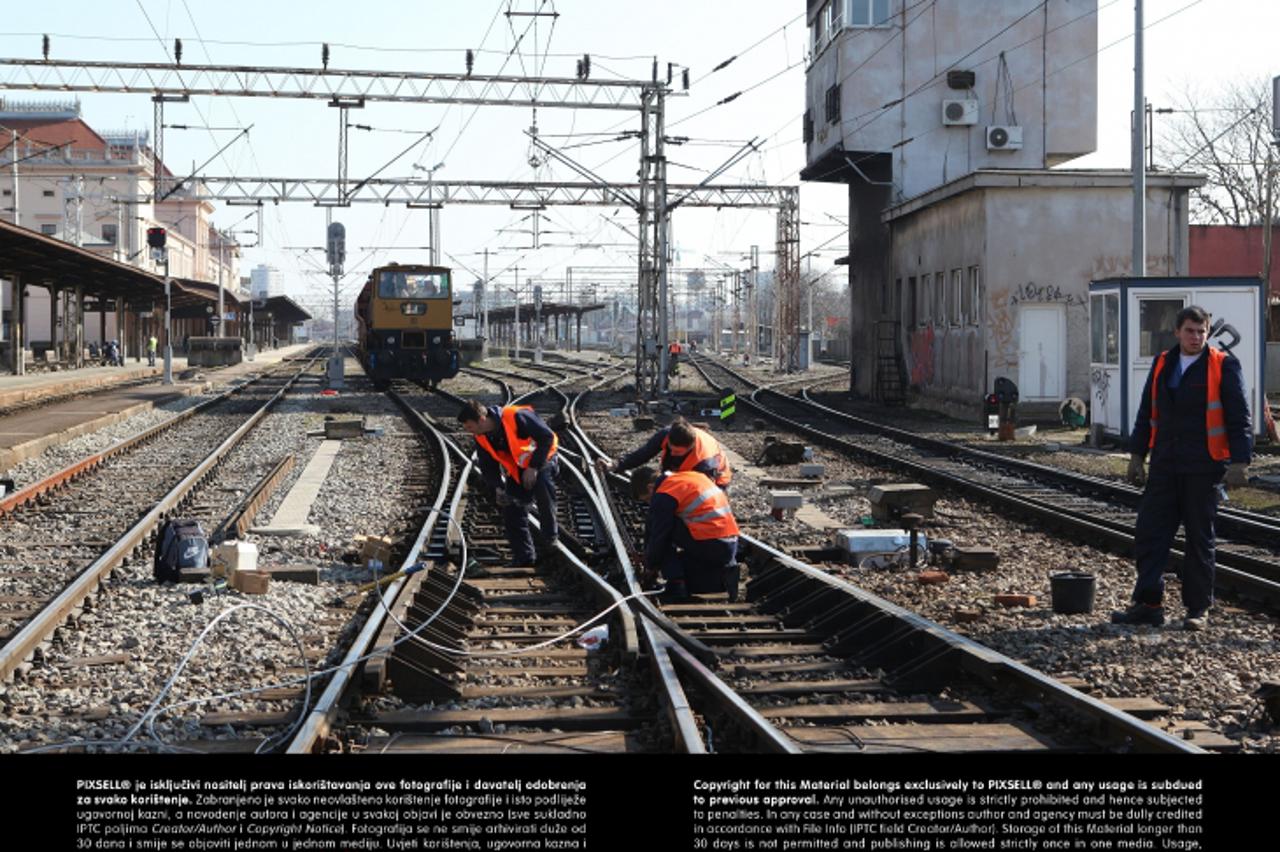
[875,173,1187,406]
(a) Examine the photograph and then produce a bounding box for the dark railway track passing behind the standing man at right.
[695,358,1280,611]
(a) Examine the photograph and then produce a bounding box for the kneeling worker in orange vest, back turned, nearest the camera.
[631,467,739,603]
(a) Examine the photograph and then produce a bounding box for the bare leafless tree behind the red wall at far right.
[1157,79,1274,225]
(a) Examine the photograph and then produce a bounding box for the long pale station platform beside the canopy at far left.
[0,344,312,475]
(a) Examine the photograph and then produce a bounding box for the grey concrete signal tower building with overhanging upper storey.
[800,0,1203,411]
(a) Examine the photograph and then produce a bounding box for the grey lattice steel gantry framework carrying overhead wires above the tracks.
[0,59,800,397]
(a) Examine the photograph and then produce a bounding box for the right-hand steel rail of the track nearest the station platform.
[0,355,320,682]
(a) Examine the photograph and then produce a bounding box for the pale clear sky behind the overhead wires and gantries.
[0,0,1280,318]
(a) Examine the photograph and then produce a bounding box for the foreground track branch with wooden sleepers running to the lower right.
[560,383,1199,753]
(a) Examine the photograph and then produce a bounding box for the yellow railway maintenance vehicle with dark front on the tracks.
[356,264,458,384]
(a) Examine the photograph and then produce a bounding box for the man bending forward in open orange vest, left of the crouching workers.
[458,399,559,565]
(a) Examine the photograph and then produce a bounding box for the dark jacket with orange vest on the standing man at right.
[1129,345,1253,473]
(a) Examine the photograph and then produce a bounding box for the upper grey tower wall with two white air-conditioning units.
[805,0,1098,200]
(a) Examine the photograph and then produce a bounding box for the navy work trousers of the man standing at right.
[1133,466,1222,613]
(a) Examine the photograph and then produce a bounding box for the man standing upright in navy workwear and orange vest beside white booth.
[1111,306,1253,631]
